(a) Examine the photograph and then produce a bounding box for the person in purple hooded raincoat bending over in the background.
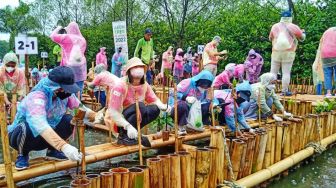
[244,49,264,84]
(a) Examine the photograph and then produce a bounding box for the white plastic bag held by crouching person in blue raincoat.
[187,100,203,130]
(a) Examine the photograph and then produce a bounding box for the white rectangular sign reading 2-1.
[15,37,38,54]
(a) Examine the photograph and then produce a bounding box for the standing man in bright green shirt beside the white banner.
[134,28,154,84]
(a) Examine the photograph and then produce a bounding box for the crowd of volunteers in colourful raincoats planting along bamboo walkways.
[0,11,332,173]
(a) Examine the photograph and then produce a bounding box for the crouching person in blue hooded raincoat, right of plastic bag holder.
[214,81,254,135]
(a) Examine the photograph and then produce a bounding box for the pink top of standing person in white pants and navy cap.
[269,22,304,52]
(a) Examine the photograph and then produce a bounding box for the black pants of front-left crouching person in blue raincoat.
[9,114,73,155]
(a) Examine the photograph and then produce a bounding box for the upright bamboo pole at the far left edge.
[0,94,15,188]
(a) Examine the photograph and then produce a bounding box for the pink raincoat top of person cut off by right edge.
[321,27,336,58]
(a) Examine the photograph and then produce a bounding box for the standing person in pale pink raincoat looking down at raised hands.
[203,36,227,76]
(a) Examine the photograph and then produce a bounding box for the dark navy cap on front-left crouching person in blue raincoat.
[48,66,80,93]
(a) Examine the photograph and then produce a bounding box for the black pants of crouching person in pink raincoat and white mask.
[118,102,160,133]
